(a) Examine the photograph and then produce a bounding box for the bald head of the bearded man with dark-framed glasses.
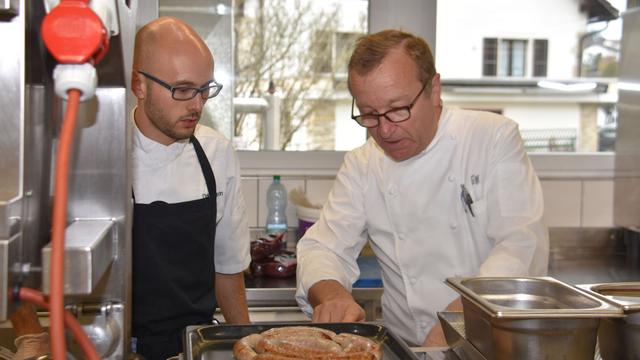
[131,17,219,145]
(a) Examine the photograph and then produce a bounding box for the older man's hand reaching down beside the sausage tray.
[309,280,365,322]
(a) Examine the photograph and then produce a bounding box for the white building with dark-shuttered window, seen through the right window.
[435,0,620,152]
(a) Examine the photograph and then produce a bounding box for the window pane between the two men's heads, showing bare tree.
[233,0,368,150]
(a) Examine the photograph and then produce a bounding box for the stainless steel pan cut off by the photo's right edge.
[578,282,640,360]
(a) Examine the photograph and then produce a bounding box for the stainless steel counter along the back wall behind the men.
[245,228,640,321]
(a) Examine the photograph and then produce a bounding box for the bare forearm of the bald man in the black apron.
[216,273,250,324]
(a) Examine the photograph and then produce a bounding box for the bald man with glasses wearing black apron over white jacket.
[131,17,250,359]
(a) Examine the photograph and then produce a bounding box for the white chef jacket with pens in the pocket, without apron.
[296,107,549,345]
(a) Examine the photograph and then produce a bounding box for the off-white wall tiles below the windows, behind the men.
[242,175,614,227]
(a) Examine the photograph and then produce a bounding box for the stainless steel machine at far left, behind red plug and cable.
[0,0,137,359]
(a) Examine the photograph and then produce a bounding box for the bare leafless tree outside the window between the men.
[234,0,362,150]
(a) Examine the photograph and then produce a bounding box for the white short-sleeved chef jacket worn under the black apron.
[133,116,251,274]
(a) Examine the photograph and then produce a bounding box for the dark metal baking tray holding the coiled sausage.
[184,322,418,360]
